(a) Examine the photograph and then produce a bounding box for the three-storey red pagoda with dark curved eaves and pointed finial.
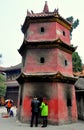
[17,1,77,125]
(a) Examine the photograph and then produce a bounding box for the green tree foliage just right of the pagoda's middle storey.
[72,52,82,72]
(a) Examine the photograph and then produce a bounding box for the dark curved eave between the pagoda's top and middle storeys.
[18,39,77,55]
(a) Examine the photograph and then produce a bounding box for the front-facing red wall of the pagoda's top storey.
[27,22,56,41]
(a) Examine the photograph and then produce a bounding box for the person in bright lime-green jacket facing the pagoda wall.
[40,98,48,127]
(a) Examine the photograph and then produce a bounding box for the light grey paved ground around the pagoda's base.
[0,108,84,130]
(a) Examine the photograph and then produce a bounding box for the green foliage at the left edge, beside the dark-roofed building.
[0,73,6,97]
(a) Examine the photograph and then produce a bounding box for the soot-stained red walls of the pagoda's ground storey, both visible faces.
[21,82,77,124]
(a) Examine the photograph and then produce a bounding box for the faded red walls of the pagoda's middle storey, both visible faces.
[23,48,72,75]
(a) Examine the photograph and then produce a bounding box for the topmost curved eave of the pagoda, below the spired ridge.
[21,14,72,34]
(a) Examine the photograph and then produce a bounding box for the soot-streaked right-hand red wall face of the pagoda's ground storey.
[58,83,77,123]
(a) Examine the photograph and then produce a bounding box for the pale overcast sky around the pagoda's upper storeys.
[0,0,84,67]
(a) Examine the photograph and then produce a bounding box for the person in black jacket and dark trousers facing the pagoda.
[30,97,40,127]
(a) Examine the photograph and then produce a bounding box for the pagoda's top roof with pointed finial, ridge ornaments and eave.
[21,1,72,34]
